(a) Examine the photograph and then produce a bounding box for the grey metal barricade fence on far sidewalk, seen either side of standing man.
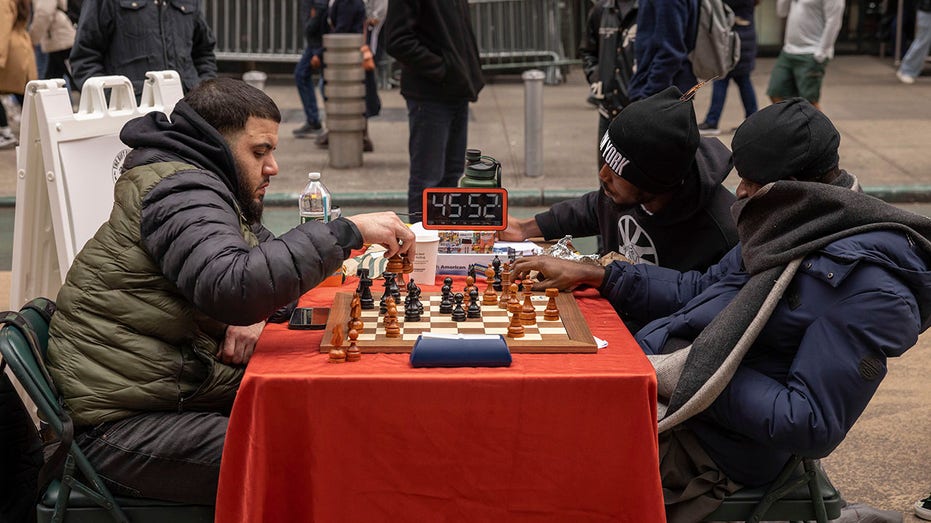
[204,0,584,83]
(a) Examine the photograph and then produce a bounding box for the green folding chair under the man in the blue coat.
[704,455,844,523]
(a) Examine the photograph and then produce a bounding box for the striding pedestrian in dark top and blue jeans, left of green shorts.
[698,0,759,135]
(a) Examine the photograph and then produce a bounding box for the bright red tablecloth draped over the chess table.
[216,279,665,523]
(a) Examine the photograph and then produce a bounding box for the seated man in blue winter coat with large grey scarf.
[515,98,931,522]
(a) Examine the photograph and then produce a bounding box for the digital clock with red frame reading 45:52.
[423,187,508,231]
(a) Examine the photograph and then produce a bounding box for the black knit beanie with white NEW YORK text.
[599,87,700,194]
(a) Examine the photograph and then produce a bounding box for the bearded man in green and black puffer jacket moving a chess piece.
[48,79,414,504]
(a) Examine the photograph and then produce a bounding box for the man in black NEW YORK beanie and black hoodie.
[500,87,737,320]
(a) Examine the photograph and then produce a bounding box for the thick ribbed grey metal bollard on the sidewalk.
[323,33,365,169]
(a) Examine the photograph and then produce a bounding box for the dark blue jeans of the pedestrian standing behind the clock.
[407,99,469,216]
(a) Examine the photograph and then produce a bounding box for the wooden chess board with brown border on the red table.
[320,292,598,353]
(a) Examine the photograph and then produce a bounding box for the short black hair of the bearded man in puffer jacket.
[184,78,281,136]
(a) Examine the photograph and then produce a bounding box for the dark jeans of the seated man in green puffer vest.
[75,412,229,505]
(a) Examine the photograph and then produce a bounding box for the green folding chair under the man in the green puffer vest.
[0,298,214,523]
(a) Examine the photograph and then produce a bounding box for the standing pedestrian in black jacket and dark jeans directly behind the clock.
[385,0,485,216]
